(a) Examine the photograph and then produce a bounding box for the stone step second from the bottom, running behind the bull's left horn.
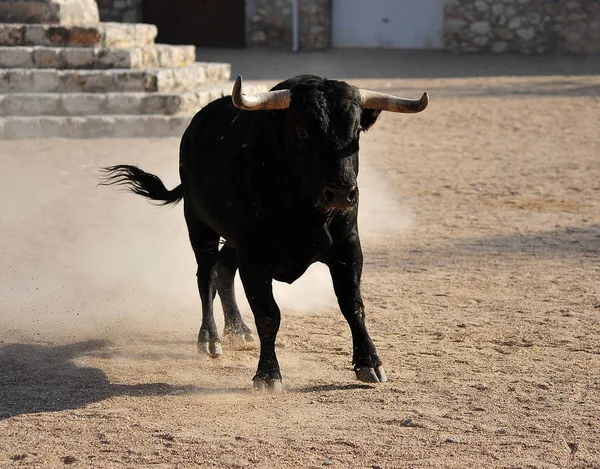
[0,82,267,116]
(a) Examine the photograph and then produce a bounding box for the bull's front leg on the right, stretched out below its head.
[328,235,387,383]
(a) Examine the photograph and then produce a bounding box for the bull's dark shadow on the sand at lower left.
[0,340,223,419]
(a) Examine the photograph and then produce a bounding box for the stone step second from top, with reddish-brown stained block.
[0,23,158,49]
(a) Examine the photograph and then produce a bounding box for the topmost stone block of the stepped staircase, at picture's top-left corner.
[0,0,100,24]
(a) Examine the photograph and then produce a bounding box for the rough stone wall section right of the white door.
[444,0,600,54]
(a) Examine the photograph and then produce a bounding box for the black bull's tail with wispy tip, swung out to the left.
[100,164,183,205]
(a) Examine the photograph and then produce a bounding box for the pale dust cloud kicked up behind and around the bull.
[0,139,411,342]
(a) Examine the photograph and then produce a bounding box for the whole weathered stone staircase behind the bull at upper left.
[0,0,264,139]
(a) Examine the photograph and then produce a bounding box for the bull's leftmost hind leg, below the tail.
[183,201,223,358]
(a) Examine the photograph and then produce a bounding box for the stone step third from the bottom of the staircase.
[0,62,231,93]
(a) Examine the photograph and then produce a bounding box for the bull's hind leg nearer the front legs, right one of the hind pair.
[217,243,254,346]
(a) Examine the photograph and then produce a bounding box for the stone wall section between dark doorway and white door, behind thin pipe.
[246,0,331,51]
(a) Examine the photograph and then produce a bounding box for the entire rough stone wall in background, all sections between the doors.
[95,0,600,54]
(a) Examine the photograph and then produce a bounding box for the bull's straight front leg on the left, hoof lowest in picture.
[239,259,283,392]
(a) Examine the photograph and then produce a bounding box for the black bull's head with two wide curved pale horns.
[232,75,429,211]
